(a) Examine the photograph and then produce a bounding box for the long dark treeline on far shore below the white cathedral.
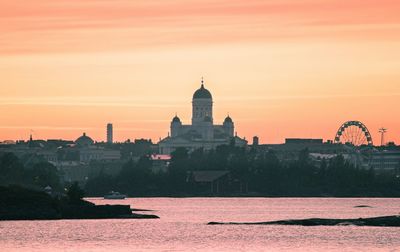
[85,146,400,197]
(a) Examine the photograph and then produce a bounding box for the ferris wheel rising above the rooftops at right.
[335,121,373,146]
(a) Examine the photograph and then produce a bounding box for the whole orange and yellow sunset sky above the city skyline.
[0,0,400,144]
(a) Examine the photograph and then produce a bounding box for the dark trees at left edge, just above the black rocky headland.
[0,153,62,191]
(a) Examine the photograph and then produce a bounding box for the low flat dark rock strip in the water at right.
[208,215,400,227]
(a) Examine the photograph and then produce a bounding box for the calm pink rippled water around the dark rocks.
[0,198,400,252]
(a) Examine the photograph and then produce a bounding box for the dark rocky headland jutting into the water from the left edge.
[0,186,159,220]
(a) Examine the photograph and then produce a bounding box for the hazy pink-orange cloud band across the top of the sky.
[0,0,400,54]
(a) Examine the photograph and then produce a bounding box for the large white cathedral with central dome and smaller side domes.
[158,80,247,154]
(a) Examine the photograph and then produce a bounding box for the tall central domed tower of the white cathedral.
[192,78,213,126]
